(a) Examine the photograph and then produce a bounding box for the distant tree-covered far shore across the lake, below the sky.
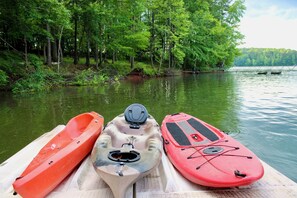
[234,48,297,66]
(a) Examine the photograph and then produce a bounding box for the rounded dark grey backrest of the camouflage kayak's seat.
[124,103,148,129]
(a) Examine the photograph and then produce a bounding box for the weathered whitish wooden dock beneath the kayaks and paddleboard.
[0,125,297,198]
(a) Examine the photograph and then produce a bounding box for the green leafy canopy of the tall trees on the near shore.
[0,0,245,69]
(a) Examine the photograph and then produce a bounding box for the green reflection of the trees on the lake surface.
[0,74,236,161]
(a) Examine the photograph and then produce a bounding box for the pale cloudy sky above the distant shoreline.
[239,0,297,50]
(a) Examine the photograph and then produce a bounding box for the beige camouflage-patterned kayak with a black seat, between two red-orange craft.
[91,104,162,198]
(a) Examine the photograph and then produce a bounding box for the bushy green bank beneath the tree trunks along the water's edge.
[0,52,163,93]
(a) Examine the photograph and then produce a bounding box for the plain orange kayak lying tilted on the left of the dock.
[13,112,104,198]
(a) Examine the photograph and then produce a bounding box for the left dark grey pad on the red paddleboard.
[166,123,191,146]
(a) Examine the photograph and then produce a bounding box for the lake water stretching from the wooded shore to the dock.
[0,71,297,182]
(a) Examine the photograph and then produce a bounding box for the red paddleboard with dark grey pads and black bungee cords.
[161,113,264,187]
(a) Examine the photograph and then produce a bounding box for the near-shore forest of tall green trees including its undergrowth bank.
[0,0,245,92]
